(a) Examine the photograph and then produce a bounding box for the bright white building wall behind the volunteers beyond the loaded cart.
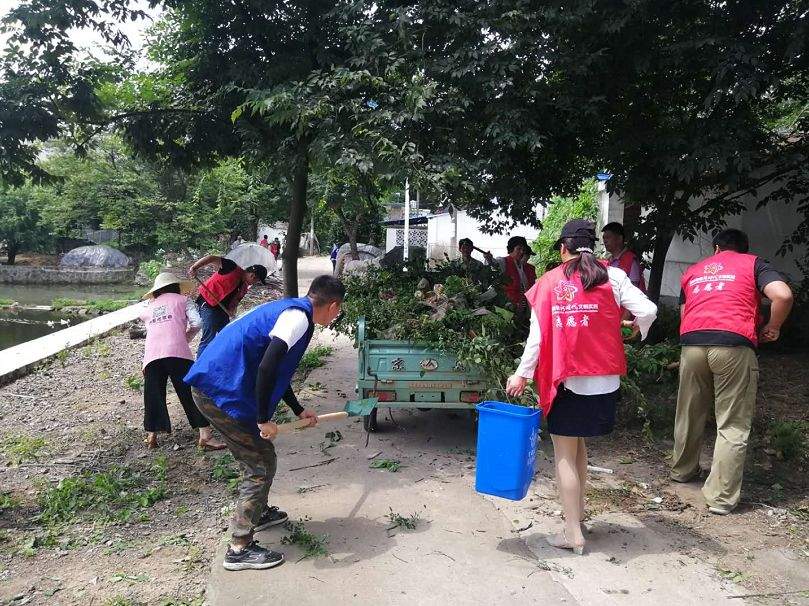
[427,211,539,261]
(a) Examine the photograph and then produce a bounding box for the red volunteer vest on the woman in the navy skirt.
[525,265,626,417]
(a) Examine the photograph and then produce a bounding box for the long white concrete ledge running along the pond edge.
[0,303,142,383]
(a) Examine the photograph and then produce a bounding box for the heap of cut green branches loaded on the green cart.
[336,261,535,403]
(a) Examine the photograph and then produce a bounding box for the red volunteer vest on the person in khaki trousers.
[680,250,761,345]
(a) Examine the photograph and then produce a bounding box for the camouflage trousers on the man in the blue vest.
[191,388,277,547]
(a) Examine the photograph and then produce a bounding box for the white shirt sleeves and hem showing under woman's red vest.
[516,267,657,396]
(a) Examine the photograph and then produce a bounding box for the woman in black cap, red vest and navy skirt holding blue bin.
[506,219,657,555]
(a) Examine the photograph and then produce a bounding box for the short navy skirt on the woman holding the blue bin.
[548,385,621,438]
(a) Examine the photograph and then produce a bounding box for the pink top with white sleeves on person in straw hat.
[140,293,201,368]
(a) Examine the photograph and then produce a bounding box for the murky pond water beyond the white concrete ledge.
[0,284,142,350]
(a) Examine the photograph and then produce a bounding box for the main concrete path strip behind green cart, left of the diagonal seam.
[207,333,575,606]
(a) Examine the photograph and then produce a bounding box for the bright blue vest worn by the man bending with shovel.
[184,297,315,424]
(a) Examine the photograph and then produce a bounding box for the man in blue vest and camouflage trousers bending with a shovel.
[185,276,345,570]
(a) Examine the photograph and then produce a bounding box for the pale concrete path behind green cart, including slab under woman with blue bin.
[207,324,747,606]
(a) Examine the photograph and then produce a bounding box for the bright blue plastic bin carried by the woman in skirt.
[475,402,542,501]
